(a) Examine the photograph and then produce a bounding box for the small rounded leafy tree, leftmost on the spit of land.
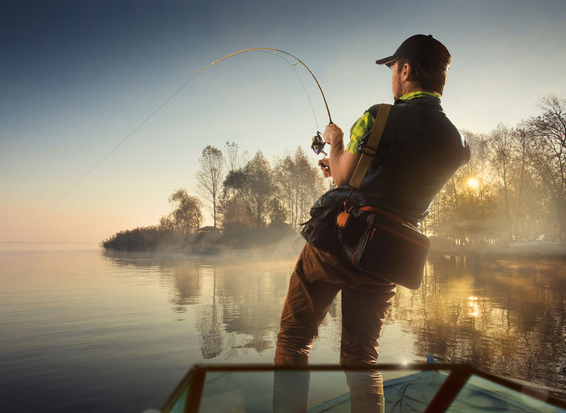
[160,189,202,234]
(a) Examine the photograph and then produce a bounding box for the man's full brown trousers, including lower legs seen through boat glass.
[273,243,397,413]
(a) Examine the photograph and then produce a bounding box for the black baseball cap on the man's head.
[375,34,451,70]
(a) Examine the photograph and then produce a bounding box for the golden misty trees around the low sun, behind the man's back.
[425,95,566,248]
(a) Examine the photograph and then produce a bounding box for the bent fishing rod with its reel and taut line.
[50,47,333,204]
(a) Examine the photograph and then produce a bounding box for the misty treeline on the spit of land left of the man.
[102,142,330,252]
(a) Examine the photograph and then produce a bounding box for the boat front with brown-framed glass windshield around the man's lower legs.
[161,363,566,413]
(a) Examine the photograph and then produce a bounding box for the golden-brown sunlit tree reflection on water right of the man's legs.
[394,257,566,394]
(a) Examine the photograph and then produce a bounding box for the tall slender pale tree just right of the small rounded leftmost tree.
[196,145,224,228]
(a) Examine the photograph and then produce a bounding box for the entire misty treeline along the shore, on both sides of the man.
[102,95,566,250]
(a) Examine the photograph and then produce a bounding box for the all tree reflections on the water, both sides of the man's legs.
[103,249,566,397]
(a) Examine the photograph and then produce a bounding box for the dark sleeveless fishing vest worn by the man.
[301,96,470,255]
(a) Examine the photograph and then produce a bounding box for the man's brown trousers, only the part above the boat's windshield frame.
[275,243,396,366]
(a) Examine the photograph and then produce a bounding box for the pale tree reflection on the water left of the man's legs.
[101,252,300,360]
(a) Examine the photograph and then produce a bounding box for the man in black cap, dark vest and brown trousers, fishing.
[274,34,470,412]
